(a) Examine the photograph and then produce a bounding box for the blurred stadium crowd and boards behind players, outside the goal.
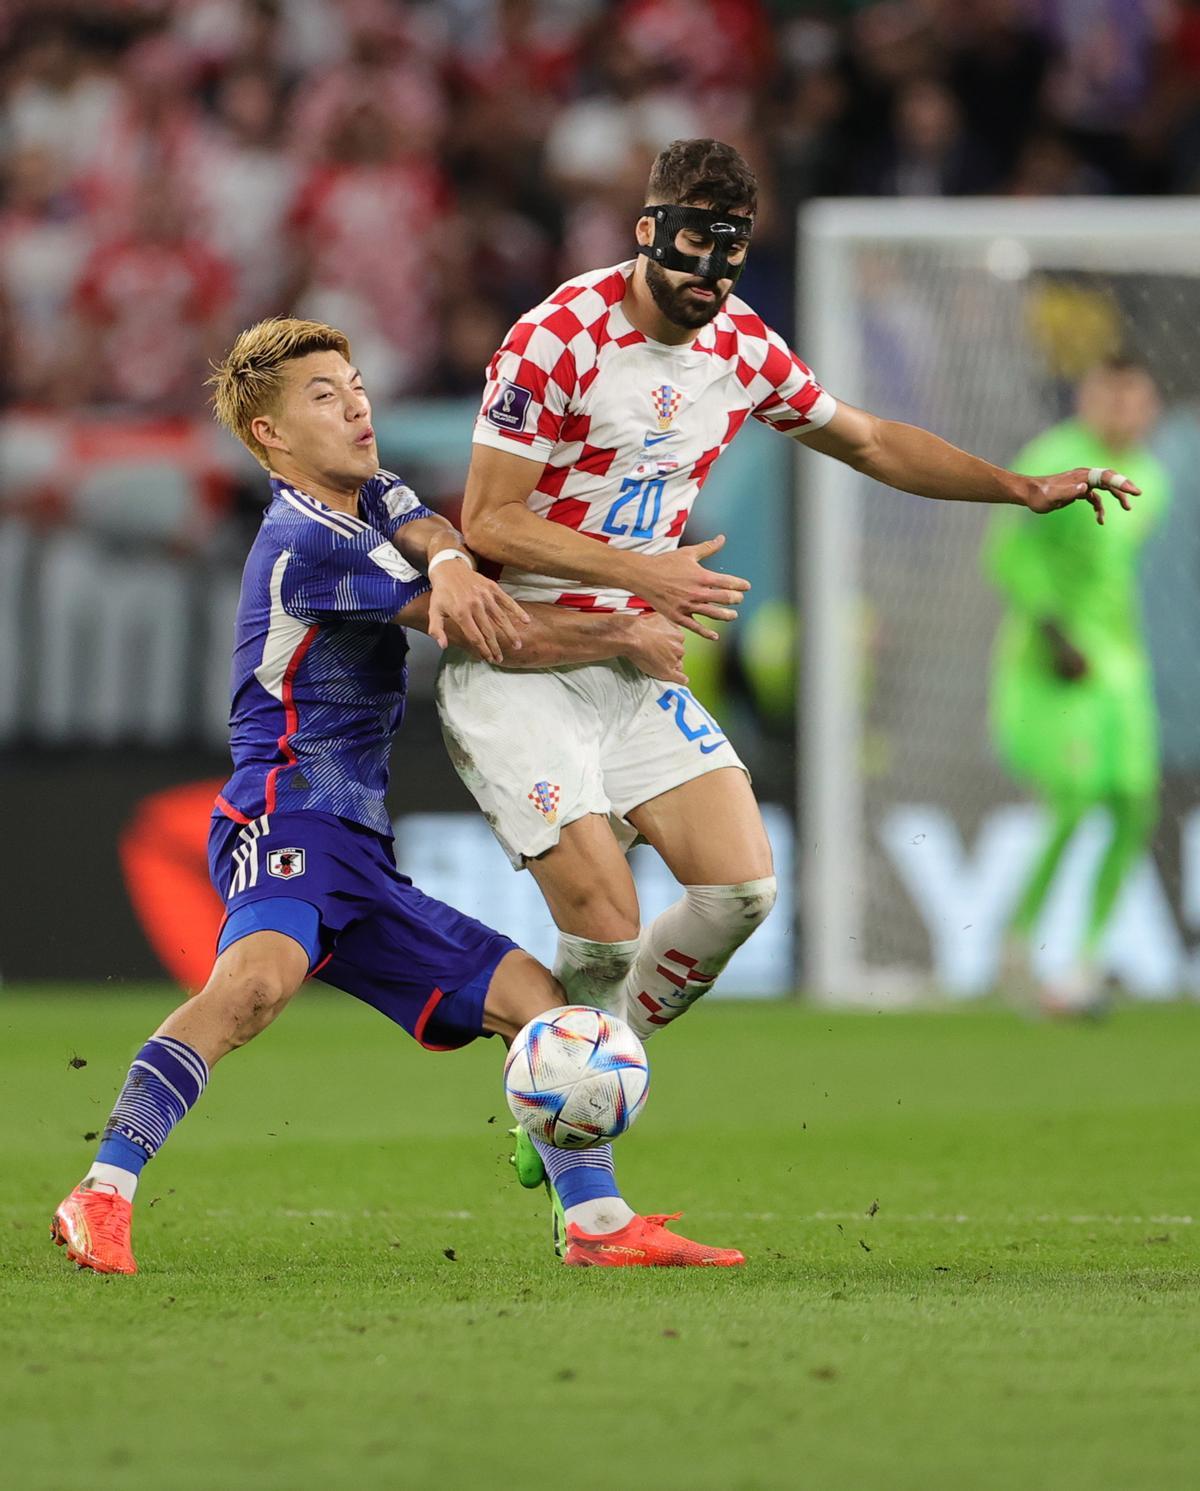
[0,0,1200,993]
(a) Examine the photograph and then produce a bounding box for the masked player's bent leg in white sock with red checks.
[614,766,777,1039]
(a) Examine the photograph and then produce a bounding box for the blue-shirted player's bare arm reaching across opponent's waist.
[395,595,687,684]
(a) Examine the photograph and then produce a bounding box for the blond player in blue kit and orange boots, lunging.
[52,318,742,1273]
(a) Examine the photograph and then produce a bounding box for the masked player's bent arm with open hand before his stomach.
[462,444,750,641]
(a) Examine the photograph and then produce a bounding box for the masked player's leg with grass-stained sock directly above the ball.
[526,813,641,1014]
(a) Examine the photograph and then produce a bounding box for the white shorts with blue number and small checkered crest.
[437,647,745,869]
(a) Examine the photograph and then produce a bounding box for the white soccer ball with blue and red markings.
[504,1005,650,1150]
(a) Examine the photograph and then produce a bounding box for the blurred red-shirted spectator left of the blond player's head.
[66,179,233,413]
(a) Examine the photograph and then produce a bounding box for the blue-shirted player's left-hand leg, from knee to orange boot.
[51,908,316,1273]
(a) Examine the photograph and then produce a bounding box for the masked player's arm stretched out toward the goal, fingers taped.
[803,403,1140,523]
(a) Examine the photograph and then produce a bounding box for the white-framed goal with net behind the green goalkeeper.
[796,200,1200,1002]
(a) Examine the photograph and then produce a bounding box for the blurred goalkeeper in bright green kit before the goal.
[984,358,1170,1012]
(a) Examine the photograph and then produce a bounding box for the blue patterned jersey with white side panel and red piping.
[218,471,432,835]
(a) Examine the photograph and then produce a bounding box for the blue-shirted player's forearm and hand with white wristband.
[392,516,529,662]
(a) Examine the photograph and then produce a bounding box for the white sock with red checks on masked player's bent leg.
[625,875,777,1041]
